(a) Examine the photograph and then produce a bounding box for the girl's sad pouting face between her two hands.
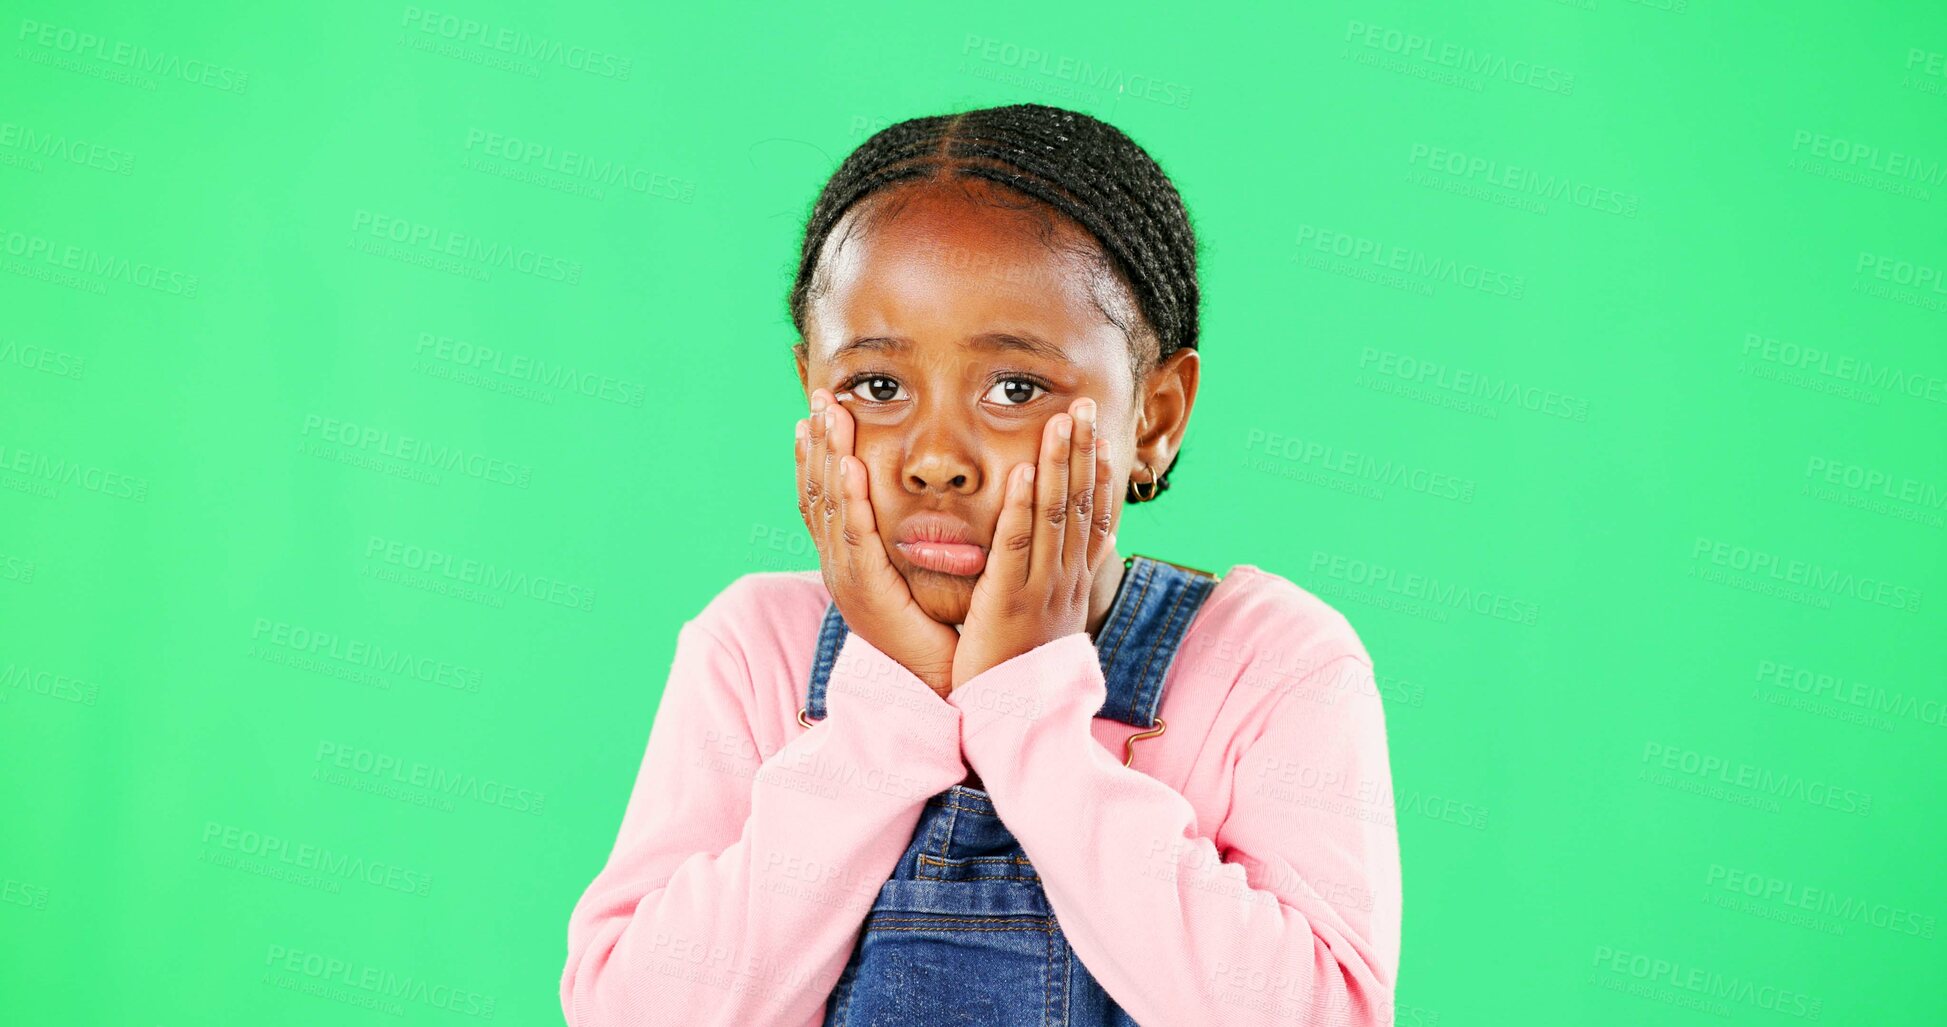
[798,183,1195,624]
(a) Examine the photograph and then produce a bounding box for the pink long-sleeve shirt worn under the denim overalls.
[561,563,1400,1027]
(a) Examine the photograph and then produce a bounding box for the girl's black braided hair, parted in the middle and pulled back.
[789,103,1199,495]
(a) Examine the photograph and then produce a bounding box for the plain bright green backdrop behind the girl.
[0,0,1947,1027]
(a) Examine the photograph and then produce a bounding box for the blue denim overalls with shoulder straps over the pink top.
[798,555,1219,1027]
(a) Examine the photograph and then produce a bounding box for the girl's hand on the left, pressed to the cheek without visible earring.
[794,388,960,700]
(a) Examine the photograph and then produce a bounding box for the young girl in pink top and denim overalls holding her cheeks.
[561,103,1400,1027]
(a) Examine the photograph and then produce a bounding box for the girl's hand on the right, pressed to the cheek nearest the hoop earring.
[952,398,1120,688]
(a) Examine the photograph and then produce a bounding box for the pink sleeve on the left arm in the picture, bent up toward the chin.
[561,622,966,1027]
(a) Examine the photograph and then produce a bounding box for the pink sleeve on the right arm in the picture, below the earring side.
[950,631,1400,1027]
